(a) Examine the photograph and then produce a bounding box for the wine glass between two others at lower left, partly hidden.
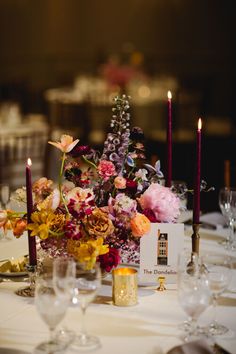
[53,257,76,342]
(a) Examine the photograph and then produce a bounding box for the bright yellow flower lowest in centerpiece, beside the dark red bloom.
[67,237,109,269]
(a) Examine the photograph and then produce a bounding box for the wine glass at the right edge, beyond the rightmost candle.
[219,188,236,249]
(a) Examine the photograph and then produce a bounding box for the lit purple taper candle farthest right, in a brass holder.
[193,118,202,224]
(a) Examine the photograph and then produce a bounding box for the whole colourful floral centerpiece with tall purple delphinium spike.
[0,95,180,272]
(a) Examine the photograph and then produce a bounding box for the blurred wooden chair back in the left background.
[0,130,48,190]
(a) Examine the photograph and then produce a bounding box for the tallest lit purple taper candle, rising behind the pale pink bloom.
[166,91,172,187]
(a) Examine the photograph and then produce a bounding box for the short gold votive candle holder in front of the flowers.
[112,268,138,306]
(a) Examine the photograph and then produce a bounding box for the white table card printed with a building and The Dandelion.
[140,223,184,283]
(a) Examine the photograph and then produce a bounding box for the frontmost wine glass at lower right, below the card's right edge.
[178,272,211,342]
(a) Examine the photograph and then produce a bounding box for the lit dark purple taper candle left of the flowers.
[25,159,37,266]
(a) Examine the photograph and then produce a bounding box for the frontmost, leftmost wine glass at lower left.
[35,274,69,353]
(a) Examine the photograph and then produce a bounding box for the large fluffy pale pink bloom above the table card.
[139,183,180,222]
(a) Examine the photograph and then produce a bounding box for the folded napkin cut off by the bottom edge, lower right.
[167,340,214,354]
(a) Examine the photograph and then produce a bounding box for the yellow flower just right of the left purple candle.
[27,209,65,240]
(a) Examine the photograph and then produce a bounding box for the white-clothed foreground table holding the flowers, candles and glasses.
[0,228,236,354]
